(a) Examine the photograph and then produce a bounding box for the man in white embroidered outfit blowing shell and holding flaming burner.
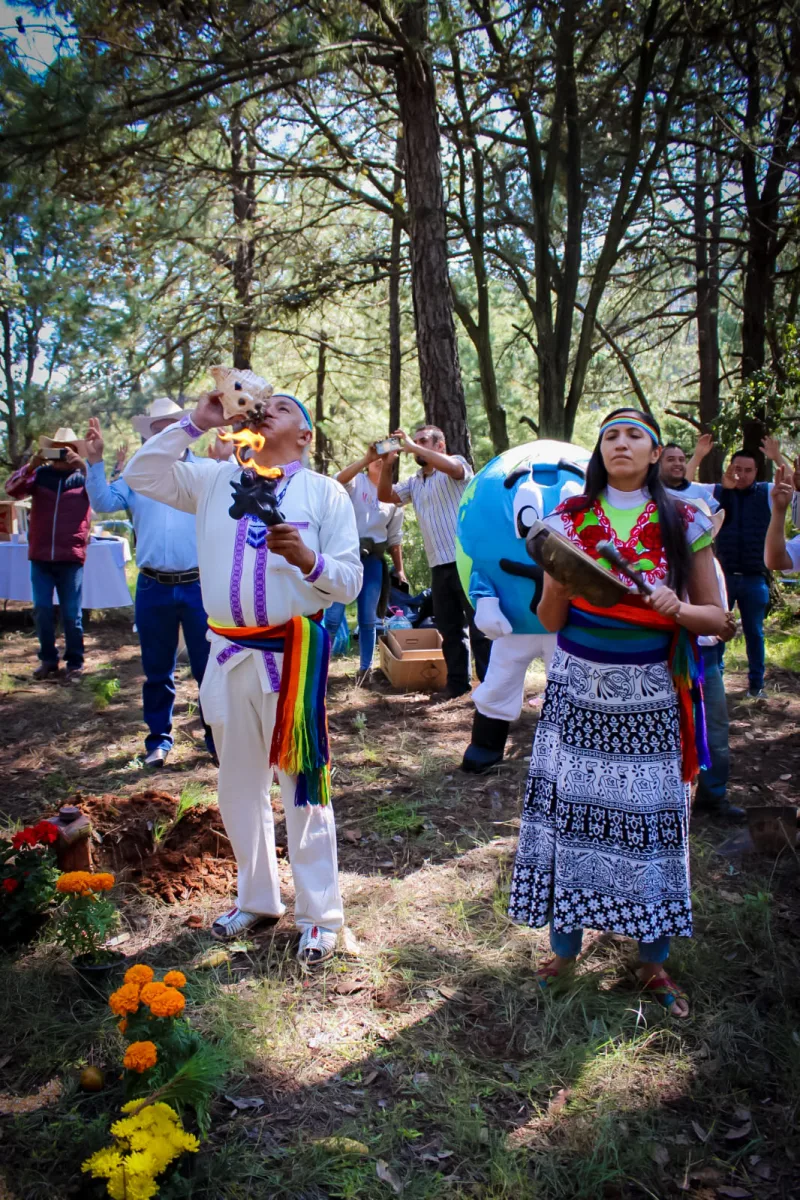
[125,376,362,965]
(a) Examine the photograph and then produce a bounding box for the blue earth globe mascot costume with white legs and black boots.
[456,440,590,773]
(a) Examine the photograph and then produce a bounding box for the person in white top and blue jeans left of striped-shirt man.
[325,438,407,688]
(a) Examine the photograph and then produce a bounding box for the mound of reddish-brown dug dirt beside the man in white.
[68,788,236,904]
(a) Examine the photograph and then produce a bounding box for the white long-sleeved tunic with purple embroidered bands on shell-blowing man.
[124,418,363,700]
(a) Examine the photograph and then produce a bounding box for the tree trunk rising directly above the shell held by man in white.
[230,107,255,370]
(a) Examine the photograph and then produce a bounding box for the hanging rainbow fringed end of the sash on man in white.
[270,617,331,808]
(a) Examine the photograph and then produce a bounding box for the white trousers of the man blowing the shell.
[203,654,344,929]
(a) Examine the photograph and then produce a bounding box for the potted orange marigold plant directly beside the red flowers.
[55,871,125,979]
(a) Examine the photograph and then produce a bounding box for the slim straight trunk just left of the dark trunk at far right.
[692,120,722,484]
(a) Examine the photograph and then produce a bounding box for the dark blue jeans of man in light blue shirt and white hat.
[136,574,213,754]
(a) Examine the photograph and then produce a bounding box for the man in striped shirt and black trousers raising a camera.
[378,425,492,697]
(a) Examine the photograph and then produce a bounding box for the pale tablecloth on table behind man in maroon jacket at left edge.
[0,538,133,608]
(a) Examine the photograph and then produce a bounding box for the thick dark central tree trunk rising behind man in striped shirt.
[396,0,471,461]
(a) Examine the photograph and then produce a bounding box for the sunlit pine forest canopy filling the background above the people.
[0,0,800,475]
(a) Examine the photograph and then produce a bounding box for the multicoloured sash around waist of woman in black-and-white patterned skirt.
[568,596,711,784]
